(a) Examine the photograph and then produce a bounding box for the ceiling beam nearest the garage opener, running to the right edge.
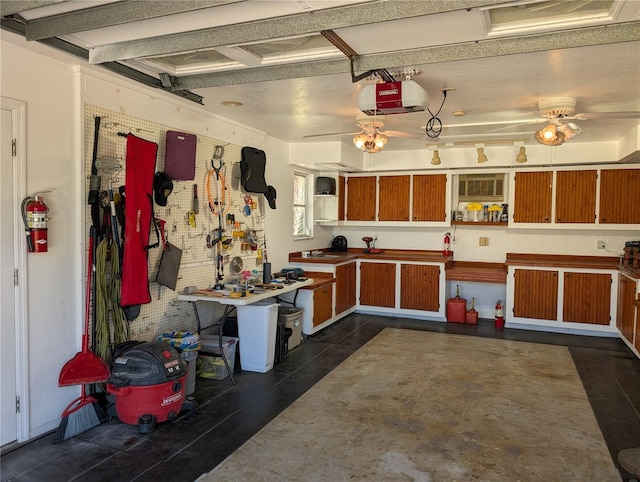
[174,21,640,90]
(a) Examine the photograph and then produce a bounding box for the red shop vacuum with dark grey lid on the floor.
[107,342,188,433]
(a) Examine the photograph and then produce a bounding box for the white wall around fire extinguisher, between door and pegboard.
[0,32,84,437]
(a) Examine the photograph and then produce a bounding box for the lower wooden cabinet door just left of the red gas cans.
[400,264,440,311]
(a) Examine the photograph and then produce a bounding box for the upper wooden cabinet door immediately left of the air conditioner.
[413,174,447,221]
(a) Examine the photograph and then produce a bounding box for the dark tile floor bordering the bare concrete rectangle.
[0,314,640,482]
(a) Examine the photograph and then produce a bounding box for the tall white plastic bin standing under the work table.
[237,300,279,373]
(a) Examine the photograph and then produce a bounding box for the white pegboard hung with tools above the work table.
[85,104,266,341]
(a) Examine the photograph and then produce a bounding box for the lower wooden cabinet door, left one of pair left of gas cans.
[360,263,396,308]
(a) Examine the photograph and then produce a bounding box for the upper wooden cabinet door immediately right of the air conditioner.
[513,171,553,223]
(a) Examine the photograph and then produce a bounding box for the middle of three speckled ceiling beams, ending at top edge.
[89,0,504,64]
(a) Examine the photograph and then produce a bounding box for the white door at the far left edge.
[0,97,28,446]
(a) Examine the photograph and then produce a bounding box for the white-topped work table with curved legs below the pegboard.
[178,279,313,385]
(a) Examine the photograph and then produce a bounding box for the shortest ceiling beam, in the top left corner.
[24,0,244,40]
